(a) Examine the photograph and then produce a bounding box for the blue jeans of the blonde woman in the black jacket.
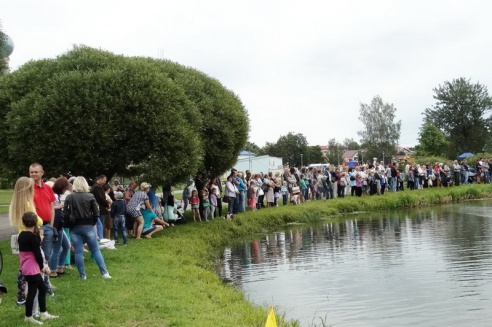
[70,225,108,278]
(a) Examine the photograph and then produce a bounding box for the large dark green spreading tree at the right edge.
[424,77,492,157]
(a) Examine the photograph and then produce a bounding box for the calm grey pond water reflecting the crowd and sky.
[219,202,492,327]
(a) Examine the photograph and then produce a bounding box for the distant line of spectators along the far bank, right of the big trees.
[183,158,484,221]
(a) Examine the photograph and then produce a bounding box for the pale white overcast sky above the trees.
[0,0,492,146]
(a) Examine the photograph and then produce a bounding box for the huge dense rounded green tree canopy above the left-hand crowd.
[0,46,249,185]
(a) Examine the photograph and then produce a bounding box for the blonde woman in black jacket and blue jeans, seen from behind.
[63,176,111,279]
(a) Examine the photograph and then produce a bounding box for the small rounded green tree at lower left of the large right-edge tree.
[418,122,450,156]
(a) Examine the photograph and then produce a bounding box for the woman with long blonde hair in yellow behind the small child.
[9,177,43,305]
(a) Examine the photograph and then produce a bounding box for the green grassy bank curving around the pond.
[0,185,492,327]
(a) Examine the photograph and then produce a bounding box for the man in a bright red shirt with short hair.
[29,162,58,294]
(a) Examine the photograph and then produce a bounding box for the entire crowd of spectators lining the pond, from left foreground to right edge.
[4,159,491,324]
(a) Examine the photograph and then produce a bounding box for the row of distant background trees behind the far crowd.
[247,78,492,166]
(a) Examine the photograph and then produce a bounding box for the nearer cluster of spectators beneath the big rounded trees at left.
[9,163,185,325]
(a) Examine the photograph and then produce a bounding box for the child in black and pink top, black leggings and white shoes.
[18,211,58,325]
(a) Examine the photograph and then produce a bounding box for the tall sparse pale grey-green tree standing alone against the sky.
[358,95,401,163]
